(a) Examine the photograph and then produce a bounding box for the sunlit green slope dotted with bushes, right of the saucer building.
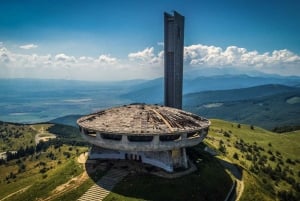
[205,120,300,201]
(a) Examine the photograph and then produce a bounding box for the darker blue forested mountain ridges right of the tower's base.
[184,85,300,129]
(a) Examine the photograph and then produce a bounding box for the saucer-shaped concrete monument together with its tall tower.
[77,12,210,172]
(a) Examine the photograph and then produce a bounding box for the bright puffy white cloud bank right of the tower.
[184,44,300,68]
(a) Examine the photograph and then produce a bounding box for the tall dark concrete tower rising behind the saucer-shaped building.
[164,12,184,109]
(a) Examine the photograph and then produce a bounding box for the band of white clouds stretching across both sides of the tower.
[0,44,300,80]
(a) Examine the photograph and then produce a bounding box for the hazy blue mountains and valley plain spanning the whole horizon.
[0,75,300,129]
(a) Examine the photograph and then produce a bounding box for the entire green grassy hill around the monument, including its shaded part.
[0,119,300,201]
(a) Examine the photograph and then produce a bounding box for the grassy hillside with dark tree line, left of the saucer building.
[0,122,93,201]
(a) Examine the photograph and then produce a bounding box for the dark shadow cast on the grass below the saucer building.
[86,152,233,201]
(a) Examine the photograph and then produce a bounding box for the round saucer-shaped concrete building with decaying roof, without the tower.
[77,104,210,172]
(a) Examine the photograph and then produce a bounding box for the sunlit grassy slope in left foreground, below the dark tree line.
[0,146,88,200]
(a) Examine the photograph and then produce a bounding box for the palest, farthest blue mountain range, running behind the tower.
[120,75,300,103]
